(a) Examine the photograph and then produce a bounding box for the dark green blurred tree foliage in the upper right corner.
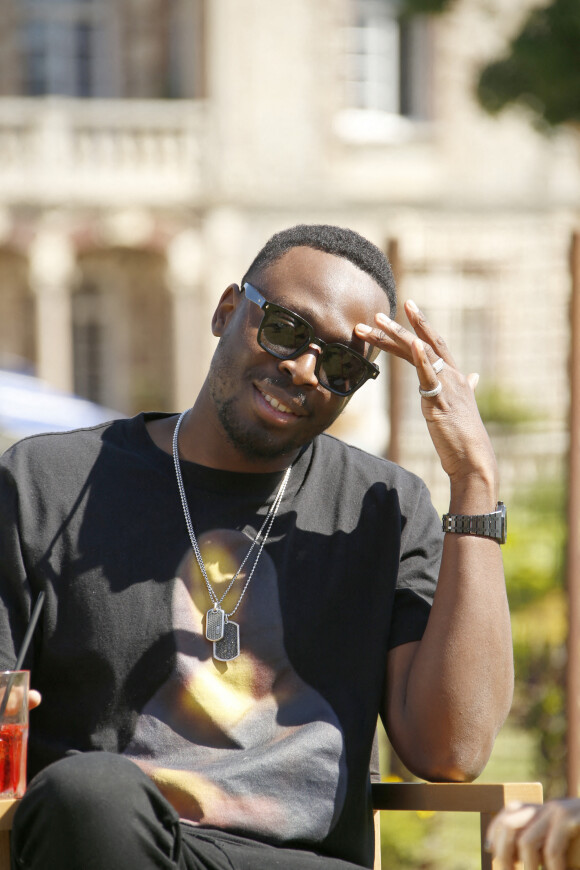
[477,0,580,127]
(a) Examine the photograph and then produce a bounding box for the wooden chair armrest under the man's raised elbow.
[372,782,543,815]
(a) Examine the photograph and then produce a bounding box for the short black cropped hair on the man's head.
[242,224,397,317]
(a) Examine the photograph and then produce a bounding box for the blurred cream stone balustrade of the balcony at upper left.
[0,98,207,207]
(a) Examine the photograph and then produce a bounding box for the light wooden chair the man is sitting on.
[0,782,580,870]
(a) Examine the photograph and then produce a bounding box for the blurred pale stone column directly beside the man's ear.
[167,229,206,410]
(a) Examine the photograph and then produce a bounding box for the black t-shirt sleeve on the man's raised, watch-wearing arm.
[389,481,443,649]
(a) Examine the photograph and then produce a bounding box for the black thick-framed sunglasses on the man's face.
[240,282,379,396]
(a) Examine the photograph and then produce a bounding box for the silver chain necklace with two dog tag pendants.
[173,409,292,662]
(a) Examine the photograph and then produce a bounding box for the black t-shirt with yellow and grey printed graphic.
[0,415,442,866]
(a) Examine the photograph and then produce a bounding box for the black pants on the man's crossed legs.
[12,752,360,870]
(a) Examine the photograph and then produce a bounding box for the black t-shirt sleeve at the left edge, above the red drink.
[0,458,31,669]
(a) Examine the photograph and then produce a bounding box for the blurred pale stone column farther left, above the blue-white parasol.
[30,229,75,392]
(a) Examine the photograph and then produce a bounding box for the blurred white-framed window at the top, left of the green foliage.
[345,0,429,119]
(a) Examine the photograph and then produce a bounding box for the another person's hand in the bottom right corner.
[487,798,580,870]
